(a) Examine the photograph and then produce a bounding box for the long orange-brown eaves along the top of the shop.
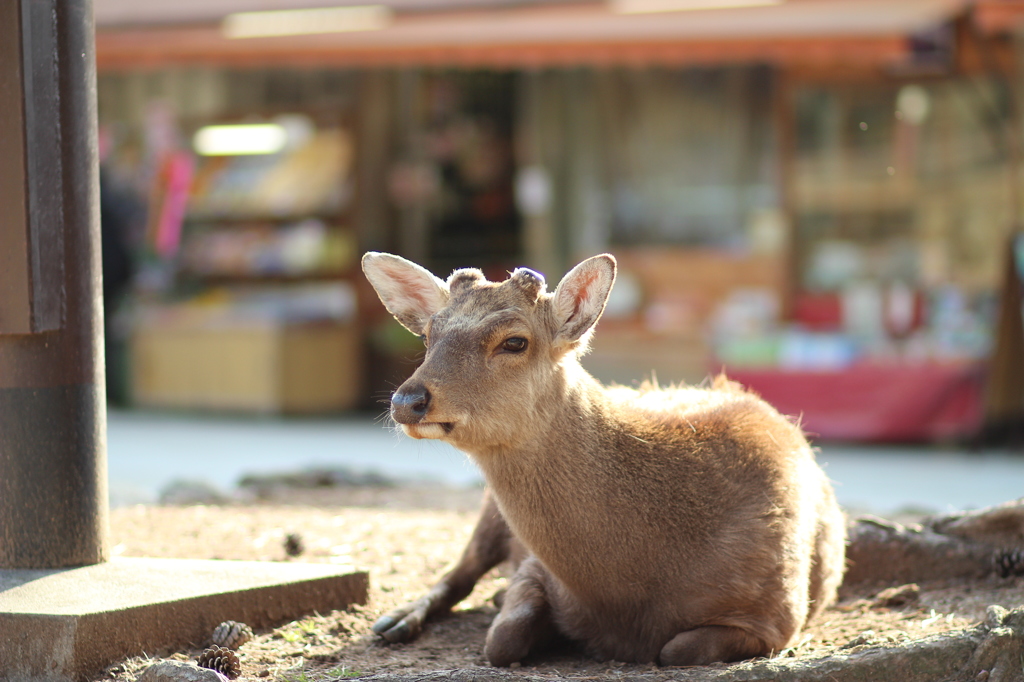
[95,0,1007,70]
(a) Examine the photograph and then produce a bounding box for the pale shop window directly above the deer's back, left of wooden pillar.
[604,68,777,248]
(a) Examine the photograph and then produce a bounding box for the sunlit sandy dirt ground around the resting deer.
[96,485,1024,682]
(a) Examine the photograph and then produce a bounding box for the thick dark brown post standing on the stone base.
[0,0,108,568]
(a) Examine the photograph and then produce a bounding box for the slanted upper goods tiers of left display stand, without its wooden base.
[178,119,355,286]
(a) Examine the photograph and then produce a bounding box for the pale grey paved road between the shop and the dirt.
[108,411,1024,514]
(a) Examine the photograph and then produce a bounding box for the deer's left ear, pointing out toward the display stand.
[362,251,449,335]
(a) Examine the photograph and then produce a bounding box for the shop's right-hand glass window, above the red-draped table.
[791,78,1003,359]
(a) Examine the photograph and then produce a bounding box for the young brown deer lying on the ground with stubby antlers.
[362,253,845,666]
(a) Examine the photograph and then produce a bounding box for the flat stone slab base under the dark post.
[0,558,370,682]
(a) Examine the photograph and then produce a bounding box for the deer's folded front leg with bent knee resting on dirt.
[483,556,557,666]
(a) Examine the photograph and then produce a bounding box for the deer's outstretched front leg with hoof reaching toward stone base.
[372,491,518,643]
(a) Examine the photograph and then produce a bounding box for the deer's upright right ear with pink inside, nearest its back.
[553,253,615,346]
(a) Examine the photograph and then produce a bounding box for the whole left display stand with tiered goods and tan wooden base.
[132,117,362,414]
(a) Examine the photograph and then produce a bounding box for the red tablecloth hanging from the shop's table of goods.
[725,364,983,442]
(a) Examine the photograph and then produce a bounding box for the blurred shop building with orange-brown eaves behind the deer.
[95,0,1024,440]
